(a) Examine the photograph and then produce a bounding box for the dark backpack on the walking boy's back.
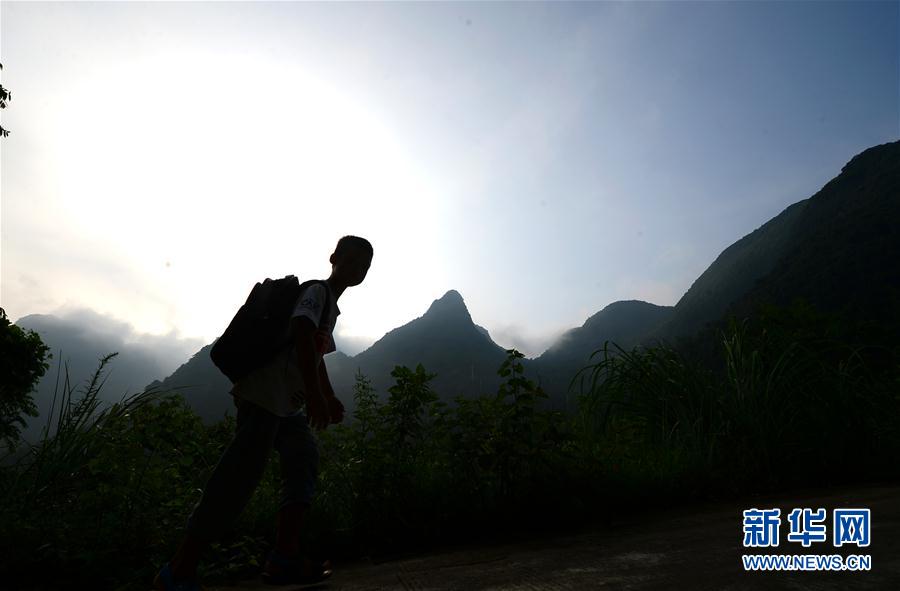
[209,275,331,383]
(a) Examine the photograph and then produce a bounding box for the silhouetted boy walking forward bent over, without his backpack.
[153,236,373,591]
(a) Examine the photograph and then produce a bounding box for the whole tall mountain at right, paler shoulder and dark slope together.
[649,142,900,350]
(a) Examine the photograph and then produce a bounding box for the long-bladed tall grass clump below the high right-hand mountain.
[573,320,900,494]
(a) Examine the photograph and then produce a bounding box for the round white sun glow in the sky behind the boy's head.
[48,51,444,340]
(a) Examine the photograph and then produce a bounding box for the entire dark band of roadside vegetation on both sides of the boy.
[0,308,900,589]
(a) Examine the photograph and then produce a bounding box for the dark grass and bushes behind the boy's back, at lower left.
[0,353,239,587]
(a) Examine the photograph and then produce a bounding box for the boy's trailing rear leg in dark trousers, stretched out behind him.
[170,401,279,580]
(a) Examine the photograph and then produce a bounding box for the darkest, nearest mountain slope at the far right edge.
[730,141,900,338]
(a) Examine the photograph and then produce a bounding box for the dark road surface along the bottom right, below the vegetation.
[210,486,900,591]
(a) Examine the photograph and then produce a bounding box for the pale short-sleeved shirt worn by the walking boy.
[231,283,341,417]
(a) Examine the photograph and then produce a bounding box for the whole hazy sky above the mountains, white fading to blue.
[0,1,900,356]
